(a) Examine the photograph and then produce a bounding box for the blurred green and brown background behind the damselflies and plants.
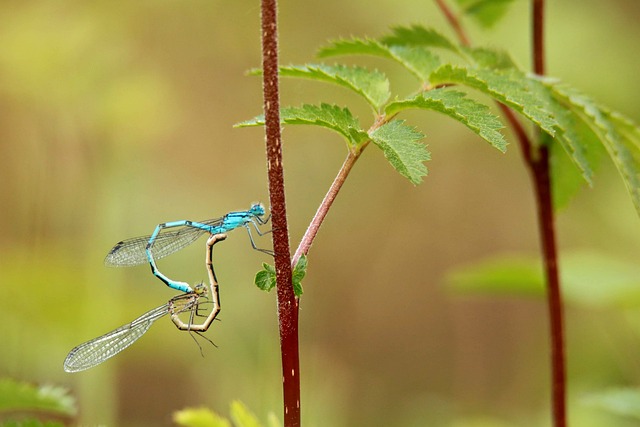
[0,0,640,426]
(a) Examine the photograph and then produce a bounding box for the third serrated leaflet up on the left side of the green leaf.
[318,38,441,82]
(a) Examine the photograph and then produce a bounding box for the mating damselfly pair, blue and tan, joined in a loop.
[64,204,271,372]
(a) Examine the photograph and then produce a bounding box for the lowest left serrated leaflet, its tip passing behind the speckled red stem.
[235,104,369,146]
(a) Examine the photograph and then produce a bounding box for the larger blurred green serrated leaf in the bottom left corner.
[0,379,77,416]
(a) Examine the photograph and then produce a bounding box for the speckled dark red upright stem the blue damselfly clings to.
[261,0,300,427]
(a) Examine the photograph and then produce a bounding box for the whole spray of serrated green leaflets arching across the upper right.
[237,24,640,212]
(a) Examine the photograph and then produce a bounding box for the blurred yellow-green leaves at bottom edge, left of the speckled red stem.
[173,401,282,427]
